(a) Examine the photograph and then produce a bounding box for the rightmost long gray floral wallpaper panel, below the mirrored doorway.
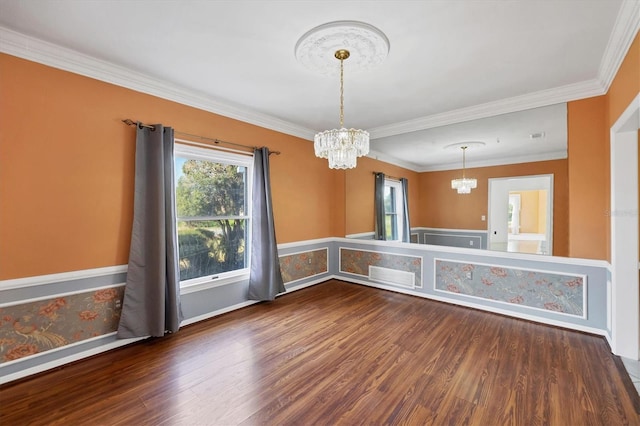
[435,259,587,318]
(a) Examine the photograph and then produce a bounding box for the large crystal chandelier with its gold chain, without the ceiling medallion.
[313,49,369,169]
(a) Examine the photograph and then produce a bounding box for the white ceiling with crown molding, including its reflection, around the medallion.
[0,0,640,171]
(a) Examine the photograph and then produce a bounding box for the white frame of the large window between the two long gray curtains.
[173,139,253,294]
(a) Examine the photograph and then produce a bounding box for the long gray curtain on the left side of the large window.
[117,123,182,338]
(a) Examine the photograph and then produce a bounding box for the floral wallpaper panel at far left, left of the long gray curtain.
[0,286,124,363]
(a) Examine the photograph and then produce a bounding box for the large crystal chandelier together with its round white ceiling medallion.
[295,21,389,169]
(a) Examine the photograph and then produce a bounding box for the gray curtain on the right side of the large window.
[249,147,285,300]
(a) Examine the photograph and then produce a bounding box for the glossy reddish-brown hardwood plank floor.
[0,281,640,426]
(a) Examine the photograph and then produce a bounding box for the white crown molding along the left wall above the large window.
[0,26,315,140]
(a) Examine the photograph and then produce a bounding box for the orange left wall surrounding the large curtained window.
[0,54,344,279]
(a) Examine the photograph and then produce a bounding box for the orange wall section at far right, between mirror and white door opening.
[567,34,640,260]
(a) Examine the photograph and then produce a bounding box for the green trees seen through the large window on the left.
[176,160,246,280]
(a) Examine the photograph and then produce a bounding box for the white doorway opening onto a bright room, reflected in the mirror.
[488,174,553,255]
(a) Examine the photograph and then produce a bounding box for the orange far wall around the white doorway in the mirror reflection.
[420,160,569,256]
